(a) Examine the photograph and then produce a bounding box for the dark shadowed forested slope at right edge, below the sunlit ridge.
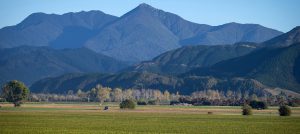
[186,43,300,92]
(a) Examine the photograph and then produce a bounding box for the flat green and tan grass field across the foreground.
[0,104,300,134]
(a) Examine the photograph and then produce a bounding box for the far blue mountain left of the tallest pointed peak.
[0,11,116,48]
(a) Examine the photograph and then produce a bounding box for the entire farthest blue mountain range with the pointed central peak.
[0,4,282,63]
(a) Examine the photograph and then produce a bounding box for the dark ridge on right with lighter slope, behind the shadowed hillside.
[124,27,300,75]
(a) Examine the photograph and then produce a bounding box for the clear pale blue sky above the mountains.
[0,0,300,32]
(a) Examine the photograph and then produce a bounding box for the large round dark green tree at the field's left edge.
[2,80,29,107]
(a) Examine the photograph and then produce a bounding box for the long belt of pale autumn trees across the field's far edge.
[6,84,300,106]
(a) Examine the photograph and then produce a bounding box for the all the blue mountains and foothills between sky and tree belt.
[0,4,300,95]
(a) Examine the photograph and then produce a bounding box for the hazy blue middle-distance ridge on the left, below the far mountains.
[0,46,127,85]
